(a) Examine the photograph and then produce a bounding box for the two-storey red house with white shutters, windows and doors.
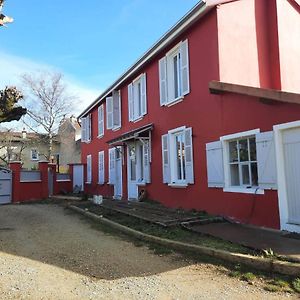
[79,0,300,232]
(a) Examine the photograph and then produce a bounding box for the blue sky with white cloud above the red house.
[0,0,198,120]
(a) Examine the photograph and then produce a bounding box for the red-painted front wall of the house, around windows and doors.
[82,2,300,228]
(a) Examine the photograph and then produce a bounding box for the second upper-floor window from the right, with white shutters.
[128,73,147,121]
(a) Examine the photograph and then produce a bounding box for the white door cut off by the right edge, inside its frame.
[282,127,300,225]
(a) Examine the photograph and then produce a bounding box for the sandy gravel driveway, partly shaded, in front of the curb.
[0,205,296,299]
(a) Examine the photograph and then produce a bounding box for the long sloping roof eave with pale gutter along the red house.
[78,0,236,118]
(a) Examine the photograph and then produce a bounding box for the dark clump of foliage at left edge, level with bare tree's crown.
[0,87,26,123]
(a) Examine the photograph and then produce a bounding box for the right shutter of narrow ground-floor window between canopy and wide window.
[184,127,194,184]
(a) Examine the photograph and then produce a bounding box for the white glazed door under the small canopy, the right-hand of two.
[127,143,138,200]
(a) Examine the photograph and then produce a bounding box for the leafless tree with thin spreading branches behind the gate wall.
[21,73,76,160]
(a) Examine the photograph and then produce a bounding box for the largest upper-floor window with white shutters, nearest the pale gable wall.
[159,40,190,106]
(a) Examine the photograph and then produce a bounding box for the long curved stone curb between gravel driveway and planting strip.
[67,205,300,276]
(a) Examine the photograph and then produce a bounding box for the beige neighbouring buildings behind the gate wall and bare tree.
[0,117,81,172]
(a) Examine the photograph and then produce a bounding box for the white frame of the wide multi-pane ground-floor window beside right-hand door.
[220,129,264,194]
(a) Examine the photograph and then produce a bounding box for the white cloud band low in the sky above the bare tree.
[0,51,101,115]
